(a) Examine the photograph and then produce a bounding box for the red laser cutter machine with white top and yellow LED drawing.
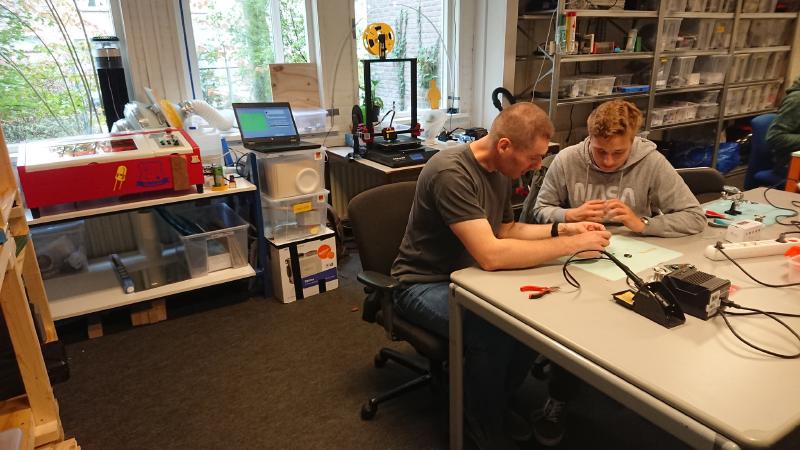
[17,128,204,217]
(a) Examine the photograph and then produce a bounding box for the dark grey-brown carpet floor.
[54,256,686,450]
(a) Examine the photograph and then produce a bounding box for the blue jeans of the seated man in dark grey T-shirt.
[394,282,535,436]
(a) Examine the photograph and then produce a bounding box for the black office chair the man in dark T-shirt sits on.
[347,181,448,420]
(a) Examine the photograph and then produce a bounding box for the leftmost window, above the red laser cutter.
[0,0,115,144]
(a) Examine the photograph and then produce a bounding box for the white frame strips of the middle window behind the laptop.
[178,0,317,100]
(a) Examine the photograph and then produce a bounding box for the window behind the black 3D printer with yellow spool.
[355,0,452,114]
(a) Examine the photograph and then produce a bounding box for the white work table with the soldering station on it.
[450,189,800,449]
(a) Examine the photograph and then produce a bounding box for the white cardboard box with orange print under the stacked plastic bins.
[268,231,339,303]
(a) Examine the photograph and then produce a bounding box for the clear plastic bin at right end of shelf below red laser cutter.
[170,203,250,278]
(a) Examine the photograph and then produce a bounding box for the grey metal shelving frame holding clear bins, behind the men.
[514,0,799,165]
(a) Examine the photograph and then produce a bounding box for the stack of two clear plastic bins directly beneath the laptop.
[257,149,328,241]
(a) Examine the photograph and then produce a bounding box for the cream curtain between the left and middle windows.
[120,0,192,102]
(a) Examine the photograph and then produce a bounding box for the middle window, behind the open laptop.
[184,0,311,108]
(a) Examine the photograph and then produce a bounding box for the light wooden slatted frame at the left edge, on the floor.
[0,124,77,449]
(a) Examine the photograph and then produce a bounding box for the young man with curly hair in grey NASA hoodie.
[534,100,706,237]
